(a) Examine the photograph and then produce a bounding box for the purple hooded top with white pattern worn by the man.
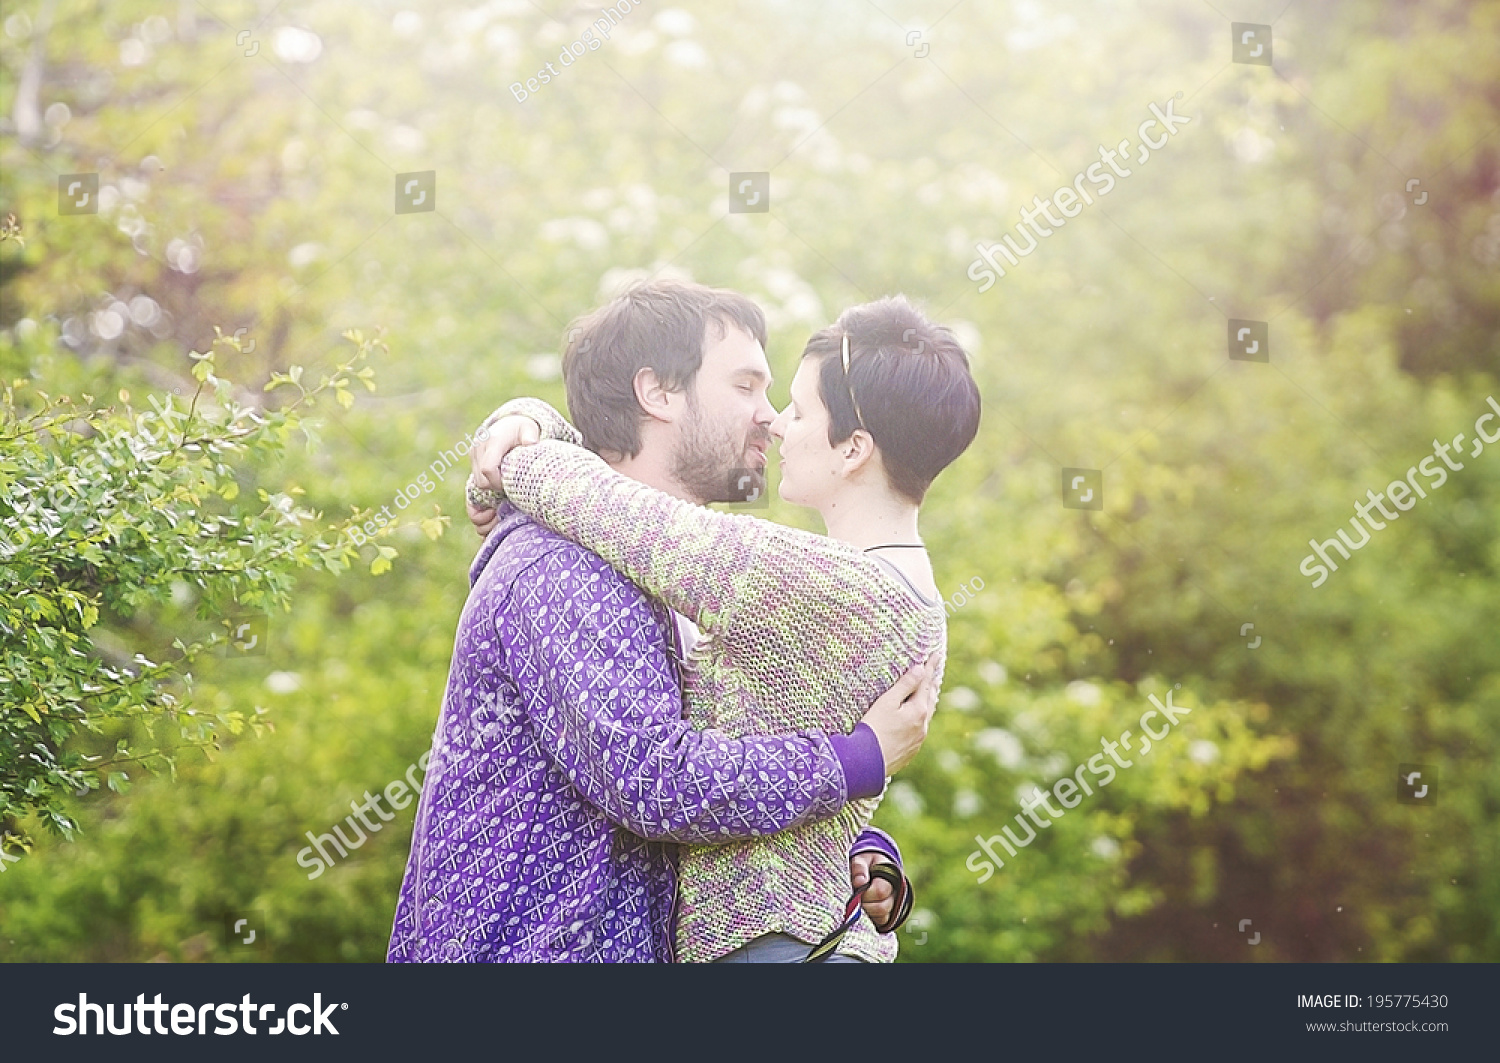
[389,505,894,963]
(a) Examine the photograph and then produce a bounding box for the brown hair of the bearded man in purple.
[563,279,767,457]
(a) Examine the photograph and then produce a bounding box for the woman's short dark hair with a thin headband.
[803,295,980,502]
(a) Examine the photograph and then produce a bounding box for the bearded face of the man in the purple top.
[672,321,776,502]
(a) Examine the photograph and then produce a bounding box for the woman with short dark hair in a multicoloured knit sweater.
[471,297,980,961]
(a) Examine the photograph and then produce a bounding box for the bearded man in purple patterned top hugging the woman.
[390,282,933,961]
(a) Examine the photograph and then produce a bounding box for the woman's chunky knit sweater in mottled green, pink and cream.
[492,400,947,963]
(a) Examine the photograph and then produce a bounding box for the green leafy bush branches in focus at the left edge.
[0,323,381,843]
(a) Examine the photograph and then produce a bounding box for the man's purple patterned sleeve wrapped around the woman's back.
[495,543,884,844]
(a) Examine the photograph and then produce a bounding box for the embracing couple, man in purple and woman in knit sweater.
[389,280,980,963]
